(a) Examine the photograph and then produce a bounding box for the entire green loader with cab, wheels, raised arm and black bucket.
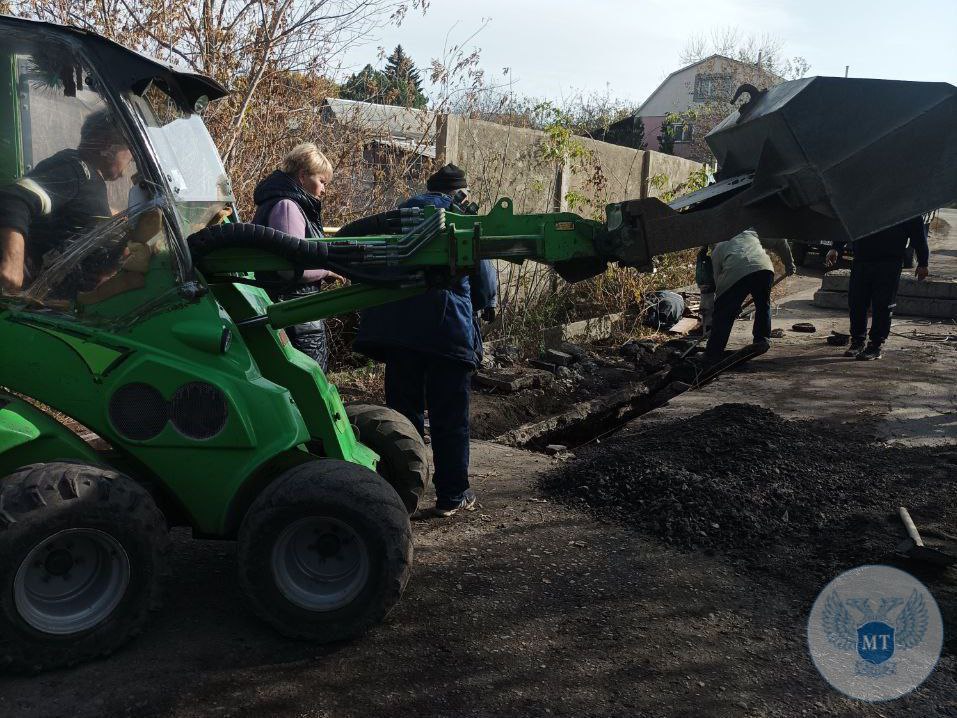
[0,18,957,671]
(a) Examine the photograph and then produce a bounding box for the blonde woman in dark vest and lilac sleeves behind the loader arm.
[253,142,342,371]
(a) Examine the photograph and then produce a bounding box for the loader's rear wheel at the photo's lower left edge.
[0,462,170,672]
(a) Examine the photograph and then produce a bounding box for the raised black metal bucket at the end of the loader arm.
[706,77,957,240]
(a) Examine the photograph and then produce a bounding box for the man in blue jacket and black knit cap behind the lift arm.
[353,164,498,517]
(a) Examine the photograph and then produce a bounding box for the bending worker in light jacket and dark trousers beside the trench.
[705,229,794,362]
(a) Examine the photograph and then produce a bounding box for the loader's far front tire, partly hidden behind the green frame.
[346,404,429,515]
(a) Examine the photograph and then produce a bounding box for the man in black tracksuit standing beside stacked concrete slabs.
[827,216,930,361]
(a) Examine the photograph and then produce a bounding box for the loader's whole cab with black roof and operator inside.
[0,18,233,327]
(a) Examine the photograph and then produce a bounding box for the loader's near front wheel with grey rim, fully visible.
[238,459,412,643]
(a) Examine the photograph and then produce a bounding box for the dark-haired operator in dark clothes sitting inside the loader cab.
[0,110,133,294]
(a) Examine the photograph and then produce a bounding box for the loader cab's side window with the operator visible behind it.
[0,30,190,324]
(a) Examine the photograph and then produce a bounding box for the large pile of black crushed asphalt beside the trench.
[541,404,953,573]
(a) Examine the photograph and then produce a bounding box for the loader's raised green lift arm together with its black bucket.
[189,77,957,329]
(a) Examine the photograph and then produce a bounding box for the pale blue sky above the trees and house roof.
[336,0,957,102]
